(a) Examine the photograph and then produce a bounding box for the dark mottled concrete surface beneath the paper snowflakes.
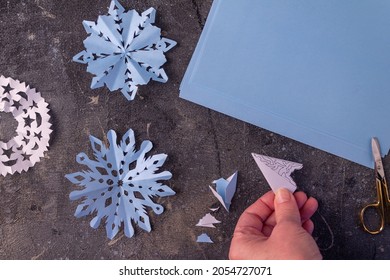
[0,0,390,259]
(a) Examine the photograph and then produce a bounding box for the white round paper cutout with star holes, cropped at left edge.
[0,76,52,176]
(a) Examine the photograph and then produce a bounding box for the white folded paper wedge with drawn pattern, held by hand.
[252,153,303,193]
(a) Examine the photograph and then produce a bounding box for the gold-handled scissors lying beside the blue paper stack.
[360,137,390,234]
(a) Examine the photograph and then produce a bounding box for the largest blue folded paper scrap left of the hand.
[209,171,238,212]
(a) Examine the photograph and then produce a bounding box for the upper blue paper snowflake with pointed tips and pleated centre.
[73,0,176,100]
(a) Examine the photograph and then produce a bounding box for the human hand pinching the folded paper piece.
[229,189,322,260]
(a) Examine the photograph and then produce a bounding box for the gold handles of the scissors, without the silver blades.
[360,178,389,234]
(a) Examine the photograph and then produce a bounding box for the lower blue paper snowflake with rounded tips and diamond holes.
[65,129,175,239]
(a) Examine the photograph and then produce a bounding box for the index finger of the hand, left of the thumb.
[234,191,275,235]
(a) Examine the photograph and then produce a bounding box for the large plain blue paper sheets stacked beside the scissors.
[180,0,390,167]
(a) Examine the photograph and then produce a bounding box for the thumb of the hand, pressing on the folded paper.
[274,188,301,226]
